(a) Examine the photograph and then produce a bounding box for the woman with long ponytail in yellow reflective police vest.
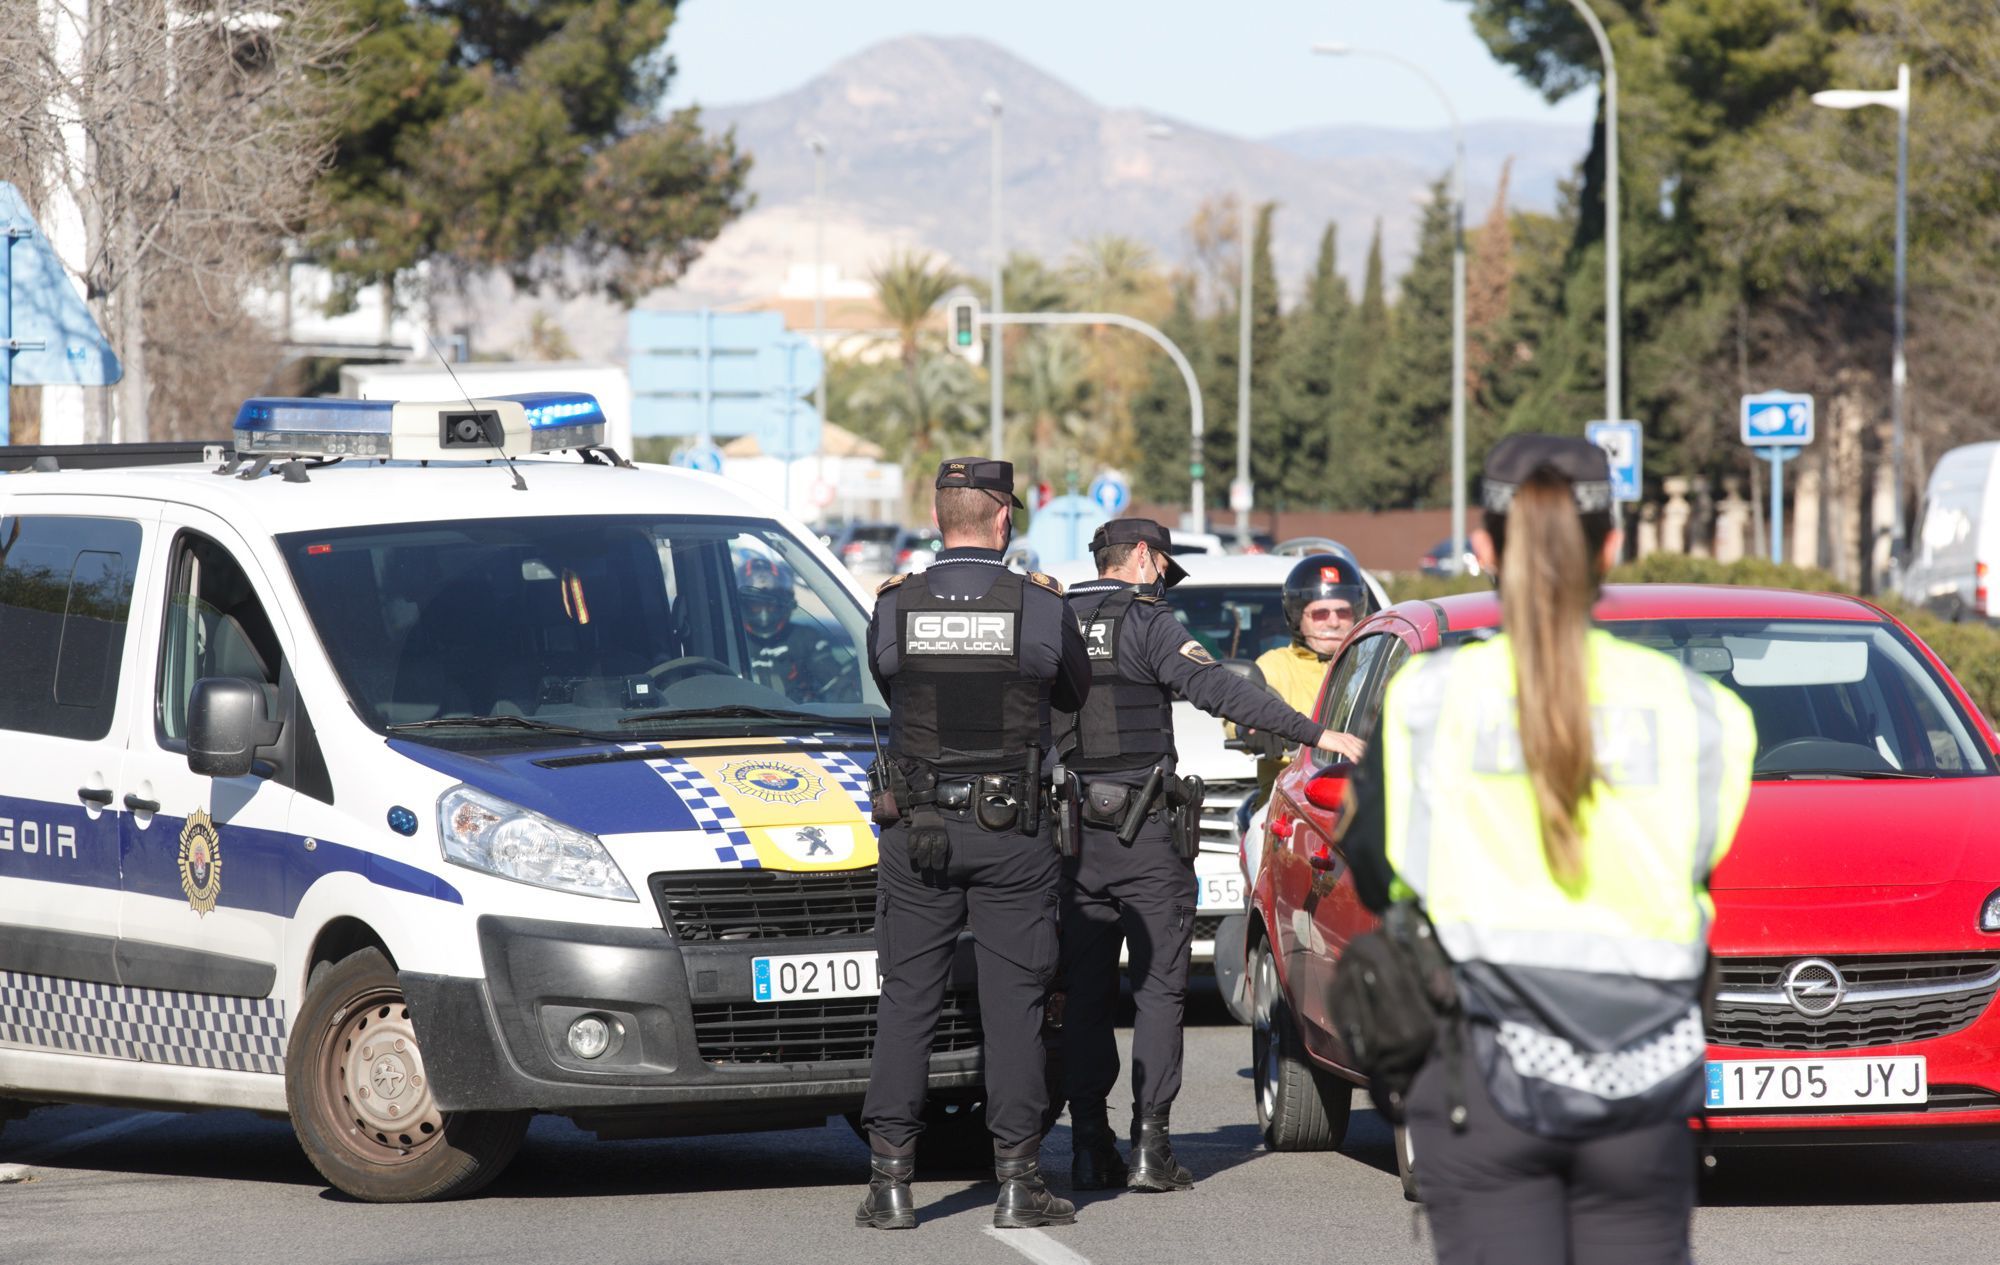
[1346,434,1756,1265]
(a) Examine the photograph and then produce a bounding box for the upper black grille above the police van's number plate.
[648,867,874,945]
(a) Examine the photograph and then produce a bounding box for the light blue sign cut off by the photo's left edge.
[0,180,124,444]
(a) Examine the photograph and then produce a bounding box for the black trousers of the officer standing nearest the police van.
[862,819,1062,1155]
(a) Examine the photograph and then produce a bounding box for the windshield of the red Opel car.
[1604,618,1992,781]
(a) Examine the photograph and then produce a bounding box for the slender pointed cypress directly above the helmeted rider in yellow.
[1278,224,1352,506]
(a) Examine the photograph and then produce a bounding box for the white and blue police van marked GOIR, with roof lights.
[0,394,980,1201]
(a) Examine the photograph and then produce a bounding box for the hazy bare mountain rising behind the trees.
[672,36,1588,306]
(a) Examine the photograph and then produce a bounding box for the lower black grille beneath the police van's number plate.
[694,991,980,1065]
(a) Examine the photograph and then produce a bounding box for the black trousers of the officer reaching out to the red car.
[1062,817,1194,1115]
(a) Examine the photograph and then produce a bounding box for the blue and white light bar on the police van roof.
[236,390,606,460]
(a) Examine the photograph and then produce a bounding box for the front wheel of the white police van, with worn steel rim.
[284,949,528,1203]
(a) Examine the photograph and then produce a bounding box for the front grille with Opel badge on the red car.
[1708,953,2000,1051]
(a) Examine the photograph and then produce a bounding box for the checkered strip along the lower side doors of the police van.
[0,971,286,1075]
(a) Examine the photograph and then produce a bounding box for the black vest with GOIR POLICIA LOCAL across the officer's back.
[888,568,1050,773]
